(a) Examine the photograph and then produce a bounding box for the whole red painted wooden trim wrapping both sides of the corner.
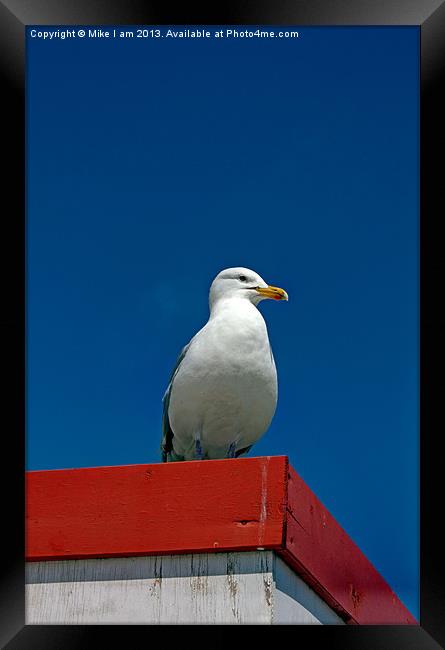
[26,456,417,625]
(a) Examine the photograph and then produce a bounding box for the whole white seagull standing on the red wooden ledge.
[161,267,288,462]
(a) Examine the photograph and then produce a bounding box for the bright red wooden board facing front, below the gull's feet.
[26,456,287,561]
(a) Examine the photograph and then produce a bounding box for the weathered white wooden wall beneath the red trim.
[26,551,342,625]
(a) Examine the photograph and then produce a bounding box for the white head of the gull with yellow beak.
[209,266,288,308]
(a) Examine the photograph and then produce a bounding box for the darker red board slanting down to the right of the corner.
[280,468,418,625]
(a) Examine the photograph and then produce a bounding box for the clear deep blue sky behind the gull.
[27,28,419,616]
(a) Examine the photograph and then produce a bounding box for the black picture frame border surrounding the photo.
[0,0,445,650]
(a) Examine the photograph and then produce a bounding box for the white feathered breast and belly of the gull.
[169,303,277,444]
